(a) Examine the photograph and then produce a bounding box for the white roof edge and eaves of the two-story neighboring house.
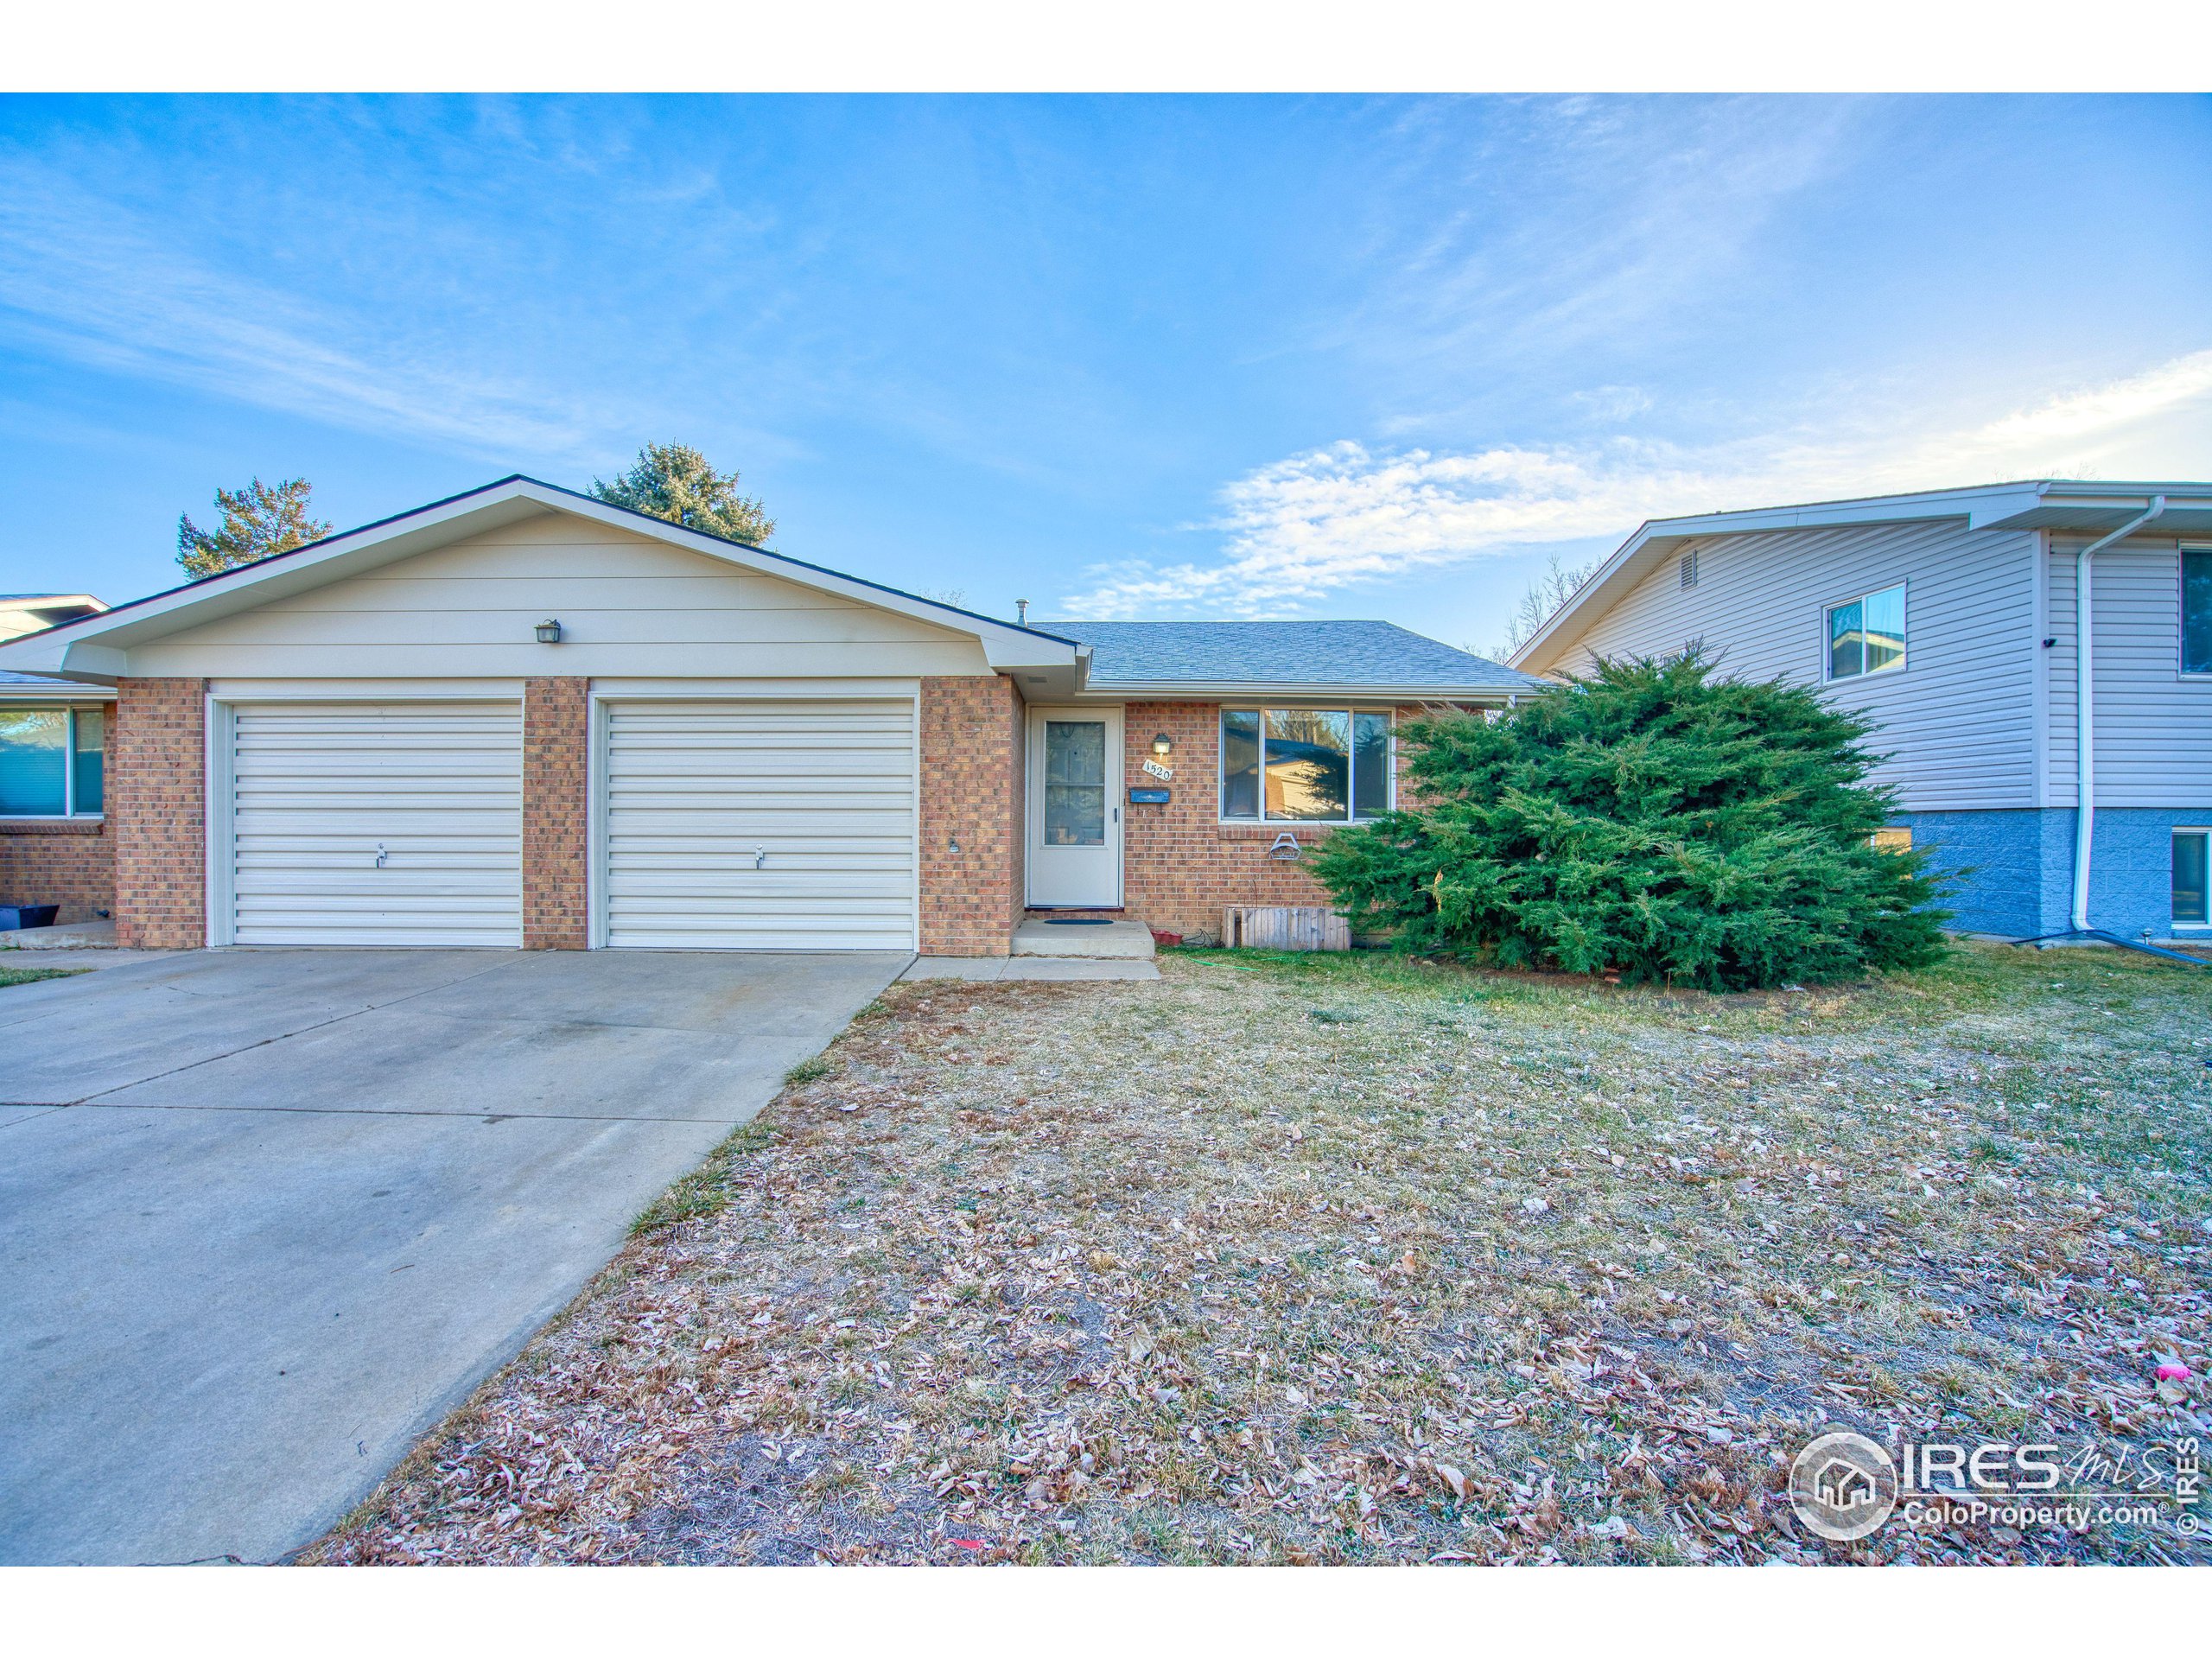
[1513,478,2212,668]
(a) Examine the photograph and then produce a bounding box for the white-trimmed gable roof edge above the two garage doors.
[0,474,1082,679]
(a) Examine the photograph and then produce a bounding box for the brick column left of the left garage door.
[106,679,208,951]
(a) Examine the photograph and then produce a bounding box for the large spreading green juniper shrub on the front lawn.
[1312,651,1947,991]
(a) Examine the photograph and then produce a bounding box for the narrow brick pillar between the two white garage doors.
[522,677,591,951]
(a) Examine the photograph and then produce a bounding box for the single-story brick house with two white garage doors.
[0,478,1540,956]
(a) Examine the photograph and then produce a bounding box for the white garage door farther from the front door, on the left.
[230,703,522,947]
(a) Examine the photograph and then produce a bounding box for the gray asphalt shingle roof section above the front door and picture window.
[1038,621,1544,690]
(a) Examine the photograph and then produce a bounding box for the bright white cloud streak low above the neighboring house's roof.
[1059,352,2212,617]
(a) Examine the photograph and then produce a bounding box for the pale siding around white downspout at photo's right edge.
[2046,536,2212,807]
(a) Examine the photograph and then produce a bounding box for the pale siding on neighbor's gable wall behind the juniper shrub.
[1557,520,2025,812]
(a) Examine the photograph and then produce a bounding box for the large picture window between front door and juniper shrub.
[1221,708,1391,823]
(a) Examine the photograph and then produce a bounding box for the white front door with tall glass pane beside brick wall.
[1024,708,1122,909]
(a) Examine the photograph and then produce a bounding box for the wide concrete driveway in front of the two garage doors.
[0,951,912,1561]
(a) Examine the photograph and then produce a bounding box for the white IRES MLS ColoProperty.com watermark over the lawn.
[1789,1429,2205,1544]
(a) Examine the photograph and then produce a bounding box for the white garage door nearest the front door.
[606,702,913,951]
